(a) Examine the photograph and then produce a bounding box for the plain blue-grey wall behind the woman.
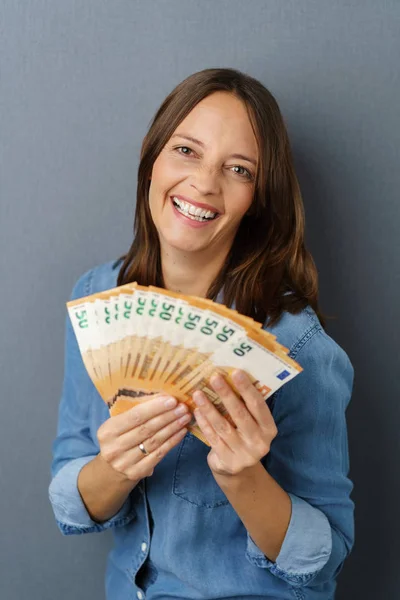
[0,0,400,600]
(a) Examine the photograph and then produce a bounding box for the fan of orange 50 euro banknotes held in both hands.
[67,283,302,443]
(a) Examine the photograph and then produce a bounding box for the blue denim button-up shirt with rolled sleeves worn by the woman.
[49,263,354,600]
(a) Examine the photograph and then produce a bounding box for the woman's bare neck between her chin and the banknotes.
[161,247,226,298]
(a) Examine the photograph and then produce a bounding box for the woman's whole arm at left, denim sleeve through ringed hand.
[49,272,190,534]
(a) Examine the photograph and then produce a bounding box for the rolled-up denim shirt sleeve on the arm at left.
[49,271,136,535]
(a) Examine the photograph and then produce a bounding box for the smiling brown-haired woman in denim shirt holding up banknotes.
[50,69,353,600]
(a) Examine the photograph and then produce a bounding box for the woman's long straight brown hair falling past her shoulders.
[118,69,323,325]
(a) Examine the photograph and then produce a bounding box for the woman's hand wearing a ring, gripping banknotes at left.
[97,394,192,482]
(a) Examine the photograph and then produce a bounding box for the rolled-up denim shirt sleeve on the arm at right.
[246,329,354,586]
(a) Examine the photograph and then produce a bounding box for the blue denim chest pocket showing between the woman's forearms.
[172,433,229,508]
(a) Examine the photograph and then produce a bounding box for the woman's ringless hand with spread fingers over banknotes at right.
[193,370,278,476]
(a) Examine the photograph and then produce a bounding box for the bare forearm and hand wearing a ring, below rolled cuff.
[78,394,191,521]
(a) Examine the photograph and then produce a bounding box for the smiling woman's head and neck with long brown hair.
[118,69,322,325]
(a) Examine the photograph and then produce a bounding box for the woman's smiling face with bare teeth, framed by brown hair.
[149,92,258,255]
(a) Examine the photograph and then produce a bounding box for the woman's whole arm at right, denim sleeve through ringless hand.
[196,329,353,586]
